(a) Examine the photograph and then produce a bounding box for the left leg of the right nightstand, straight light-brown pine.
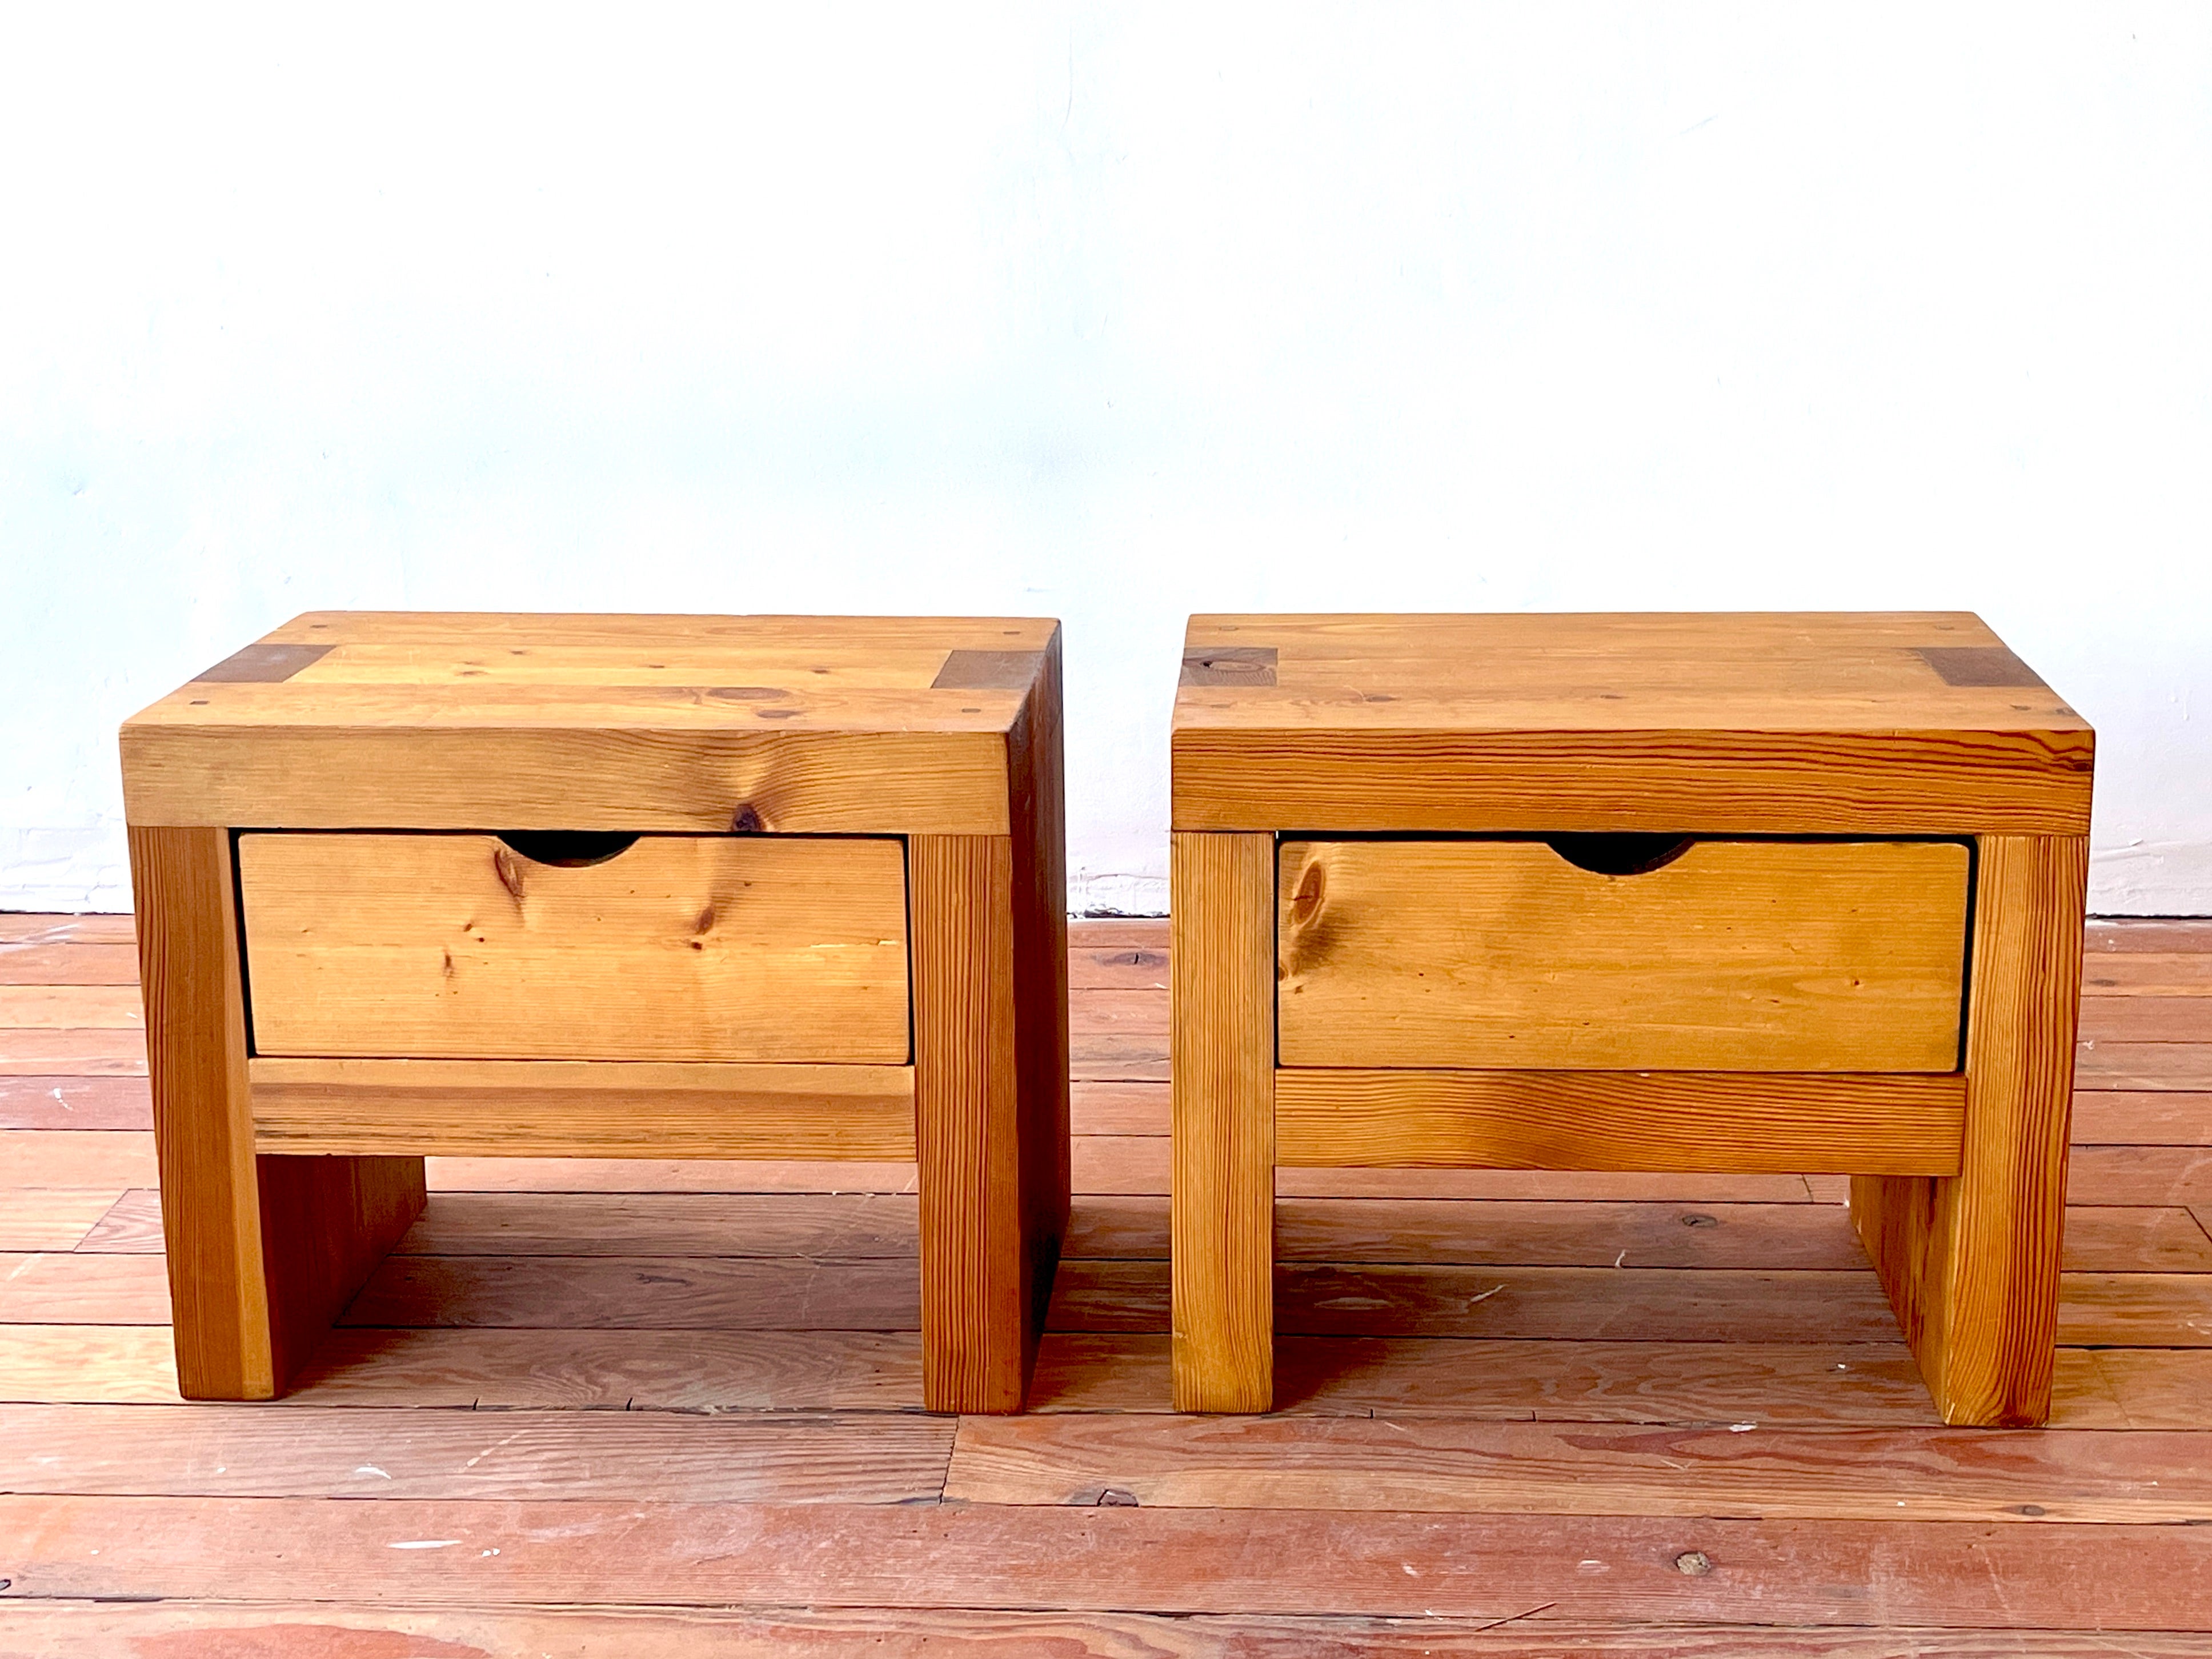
[1170,834,1274,1411]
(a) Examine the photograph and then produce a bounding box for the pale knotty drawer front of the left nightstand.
[239,832,909,1064]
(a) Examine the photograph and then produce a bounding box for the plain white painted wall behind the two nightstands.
[0,5,2212,911]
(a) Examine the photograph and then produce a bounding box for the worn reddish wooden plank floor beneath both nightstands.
[0,916,2212,1659]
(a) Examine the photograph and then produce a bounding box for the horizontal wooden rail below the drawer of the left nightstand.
[246,1060,913,1159]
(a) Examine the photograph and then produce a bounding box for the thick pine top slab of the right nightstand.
[1172,613,2095,834]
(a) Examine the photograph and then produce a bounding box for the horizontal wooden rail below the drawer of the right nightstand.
[1274,1068,1966,1175]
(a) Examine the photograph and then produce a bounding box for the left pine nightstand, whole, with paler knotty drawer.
[122,613,1068,1411]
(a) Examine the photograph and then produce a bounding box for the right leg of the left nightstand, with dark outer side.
[907,836,1068,1411]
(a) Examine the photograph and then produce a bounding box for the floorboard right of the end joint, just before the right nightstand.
[944,1413,2212,1526]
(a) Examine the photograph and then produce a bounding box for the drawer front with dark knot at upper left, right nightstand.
[1276,840,1969,1073]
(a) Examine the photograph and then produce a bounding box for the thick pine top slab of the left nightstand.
[122,611,1060,834]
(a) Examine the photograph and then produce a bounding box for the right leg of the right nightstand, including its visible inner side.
[1852,836,2088,1426]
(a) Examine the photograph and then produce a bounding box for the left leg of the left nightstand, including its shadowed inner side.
[130,827,423,1400]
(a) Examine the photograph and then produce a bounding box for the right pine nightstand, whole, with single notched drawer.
[1172,615,2095,1425]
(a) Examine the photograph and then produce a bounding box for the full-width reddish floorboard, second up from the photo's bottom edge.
[0,1497,2212,1637]
